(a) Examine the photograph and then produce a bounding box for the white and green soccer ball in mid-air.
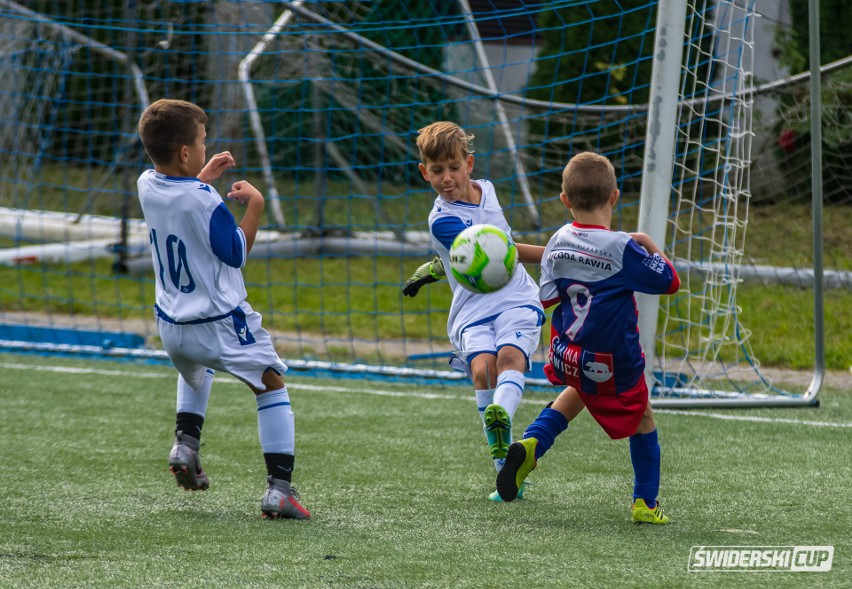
[450,225,518,294]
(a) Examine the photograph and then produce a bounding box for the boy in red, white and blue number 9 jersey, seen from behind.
[497,152,680,524]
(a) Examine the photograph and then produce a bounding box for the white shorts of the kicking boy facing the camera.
[450,307,544,375]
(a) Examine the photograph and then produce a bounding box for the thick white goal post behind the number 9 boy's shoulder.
[636,0,686,388]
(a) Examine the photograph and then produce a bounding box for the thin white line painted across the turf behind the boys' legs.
[6,362,852,428]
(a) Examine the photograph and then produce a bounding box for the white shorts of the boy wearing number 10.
[157,301,287,391]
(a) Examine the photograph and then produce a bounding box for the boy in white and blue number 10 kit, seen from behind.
[137,100,310,519]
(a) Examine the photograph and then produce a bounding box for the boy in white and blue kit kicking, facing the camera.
[417,122,544,501]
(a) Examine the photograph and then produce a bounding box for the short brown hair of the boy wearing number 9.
[562,151,618,211]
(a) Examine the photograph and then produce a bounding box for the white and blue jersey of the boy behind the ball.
[429,180,544,350]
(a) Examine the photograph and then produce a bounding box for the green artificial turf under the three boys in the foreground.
[0,355,852,588]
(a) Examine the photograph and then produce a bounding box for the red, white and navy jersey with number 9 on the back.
[540,223,680,394]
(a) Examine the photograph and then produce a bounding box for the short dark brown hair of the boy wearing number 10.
[139,98,207,164]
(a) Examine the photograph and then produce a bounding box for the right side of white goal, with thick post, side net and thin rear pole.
[637,0,825,407]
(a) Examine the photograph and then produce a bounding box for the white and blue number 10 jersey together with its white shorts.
[137,170,287,391]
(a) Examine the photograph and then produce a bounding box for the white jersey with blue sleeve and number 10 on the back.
[136,170,247,323]
